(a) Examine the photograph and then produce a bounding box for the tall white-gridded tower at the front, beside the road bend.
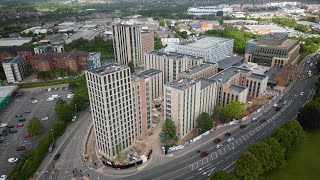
[86,63,138,159]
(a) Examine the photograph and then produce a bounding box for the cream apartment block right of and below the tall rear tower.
[144,51,204,83]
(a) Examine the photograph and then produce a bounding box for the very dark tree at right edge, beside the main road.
[298,98,320,130]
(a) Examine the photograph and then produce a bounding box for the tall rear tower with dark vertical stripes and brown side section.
[112,21,154,65]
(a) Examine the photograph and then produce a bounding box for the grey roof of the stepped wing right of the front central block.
[209,67,250,84]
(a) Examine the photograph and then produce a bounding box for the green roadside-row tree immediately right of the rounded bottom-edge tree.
[263,137,285,169]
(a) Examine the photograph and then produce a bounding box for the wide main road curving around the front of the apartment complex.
[38,52,317,180]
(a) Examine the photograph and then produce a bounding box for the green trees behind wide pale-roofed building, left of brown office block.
[204,27,260,54]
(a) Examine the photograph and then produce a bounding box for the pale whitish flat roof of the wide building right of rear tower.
[181,36,233,49]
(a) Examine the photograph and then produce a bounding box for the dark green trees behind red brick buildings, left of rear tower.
[64,36,114,59]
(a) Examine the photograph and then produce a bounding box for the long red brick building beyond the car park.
[31,49,88,72]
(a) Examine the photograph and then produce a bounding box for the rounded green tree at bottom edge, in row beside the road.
[235,152,262,180]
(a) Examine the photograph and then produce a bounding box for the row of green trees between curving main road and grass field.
[211,120,305,180]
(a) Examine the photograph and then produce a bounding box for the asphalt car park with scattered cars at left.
[0,85,70,175]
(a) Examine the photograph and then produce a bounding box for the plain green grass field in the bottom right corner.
[261,131,320,180]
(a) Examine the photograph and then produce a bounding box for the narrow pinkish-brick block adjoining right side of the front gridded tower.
[132,69,163,139]
